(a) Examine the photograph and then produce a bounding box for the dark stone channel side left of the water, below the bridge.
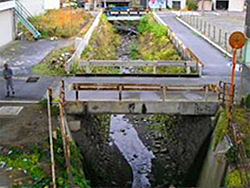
[72,115,132,187]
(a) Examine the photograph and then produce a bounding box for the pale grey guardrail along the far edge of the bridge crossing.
[79,60,201,74]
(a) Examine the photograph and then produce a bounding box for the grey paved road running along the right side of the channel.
[157,12,234,79]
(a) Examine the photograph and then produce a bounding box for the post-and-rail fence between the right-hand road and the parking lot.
[179,14,244,59]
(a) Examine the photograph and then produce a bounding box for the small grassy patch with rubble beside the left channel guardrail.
[32,46,75,76]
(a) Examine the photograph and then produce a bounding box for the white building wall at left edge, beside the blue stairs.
[0,9,15,47]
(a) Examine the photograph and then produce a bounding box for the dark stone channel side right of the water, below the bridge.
[127,115,212,187]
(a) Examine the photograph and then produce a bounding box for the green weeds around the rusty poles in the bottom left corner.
[0,130,89,188]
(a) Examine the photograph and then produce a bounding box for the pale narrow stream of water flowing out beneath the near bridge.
[110,115,154,187]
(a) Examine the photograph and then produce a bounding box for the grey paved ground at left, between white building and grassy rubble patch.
[0,39,74,77]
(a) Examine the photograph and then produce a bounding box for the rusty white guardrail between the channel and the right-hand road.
[153,12,204,76]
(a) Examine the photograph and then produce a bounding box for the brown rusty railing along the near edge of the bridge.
[72,83,217,102]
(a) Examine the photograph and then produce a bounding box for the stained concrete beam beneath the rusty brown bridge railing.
[65,101,219,116]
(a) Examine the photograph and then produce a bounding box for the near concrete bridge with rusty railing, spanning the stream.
[60,81,225,115]
